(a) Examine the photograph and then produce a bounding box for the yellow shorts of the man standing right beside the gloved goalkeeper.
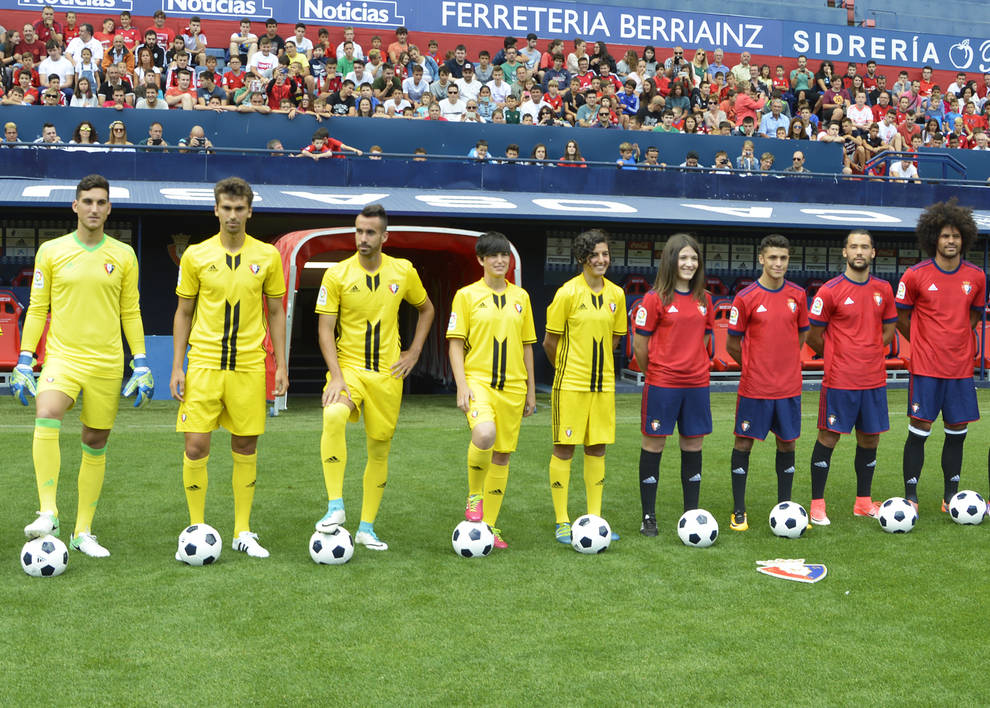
[175,366,266,437]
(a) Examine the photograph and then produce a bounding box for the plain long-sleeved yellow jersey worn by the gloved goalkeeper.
[21,232,145,376]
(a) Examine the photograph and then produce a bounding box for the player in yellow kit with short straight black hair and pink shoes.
[447,231,536,548]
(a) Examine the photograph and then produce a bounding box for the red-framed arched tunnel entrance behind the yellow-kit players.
[274,225,522,410]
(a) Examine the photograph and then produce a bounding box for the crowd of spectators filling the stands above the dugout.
[0,6,990,174]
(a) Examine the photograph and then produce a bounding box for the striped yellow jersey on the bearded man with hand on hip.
[316,253,426,373]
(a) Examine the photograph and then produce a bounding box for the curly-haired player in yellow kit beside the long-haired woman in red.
[543,229,626,544]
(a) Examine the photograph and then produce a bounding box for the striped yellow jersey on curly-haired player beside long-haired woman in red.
[547,274,626,391]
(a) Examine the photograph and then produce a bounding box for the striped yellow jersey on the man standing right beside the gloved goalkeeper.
[175,234,285,372]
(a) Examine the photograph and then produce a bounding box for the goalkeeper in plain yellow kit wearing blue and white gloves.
[11,175,155,558]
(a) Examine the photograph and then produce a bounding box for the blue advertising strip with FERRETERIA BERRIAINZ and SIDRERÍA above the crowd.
[11,0,990,73]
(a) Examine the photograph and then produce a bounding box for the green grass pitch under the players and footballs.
[0,390,990,706]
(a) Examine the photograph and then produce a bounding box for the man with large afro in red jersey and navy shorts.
[895,199,986,511]
